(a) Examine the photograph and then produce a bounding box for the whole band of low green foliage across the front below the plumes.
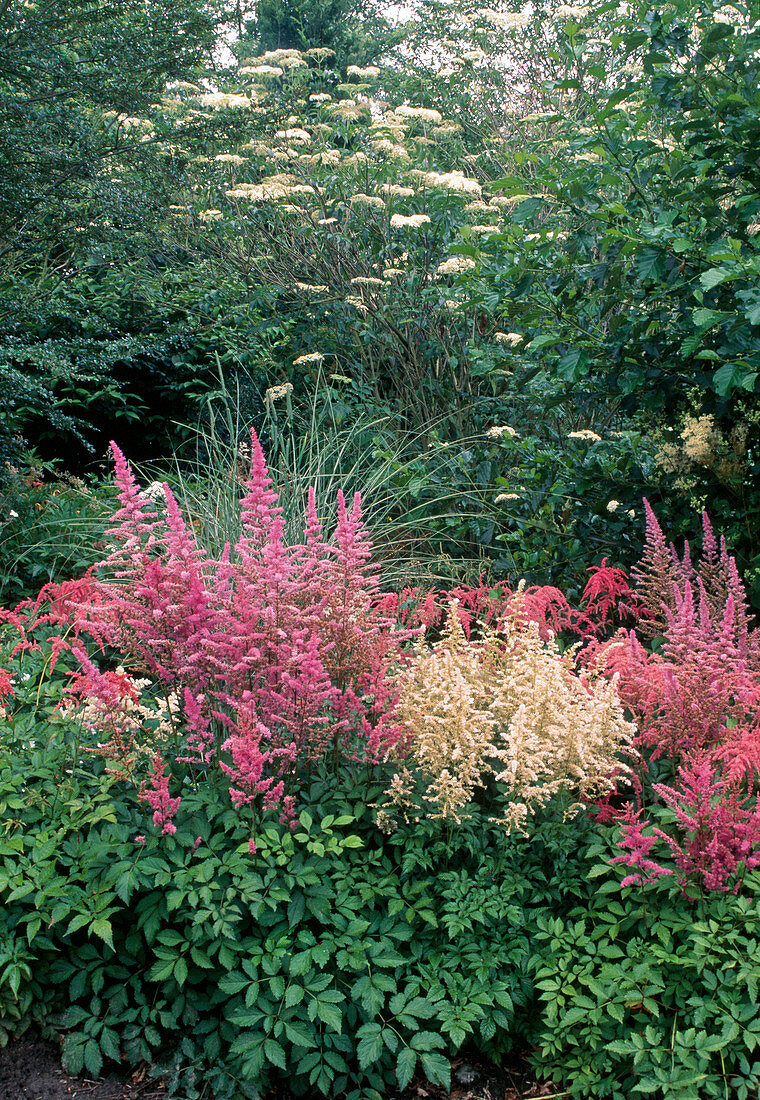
[0,607,760,1100]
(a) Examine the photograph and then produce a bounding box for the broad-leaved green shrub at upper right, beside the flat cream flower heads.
[475,0,760,594]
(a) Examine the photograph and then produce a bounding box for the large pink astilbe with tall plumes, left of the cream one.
[58,433,408,832]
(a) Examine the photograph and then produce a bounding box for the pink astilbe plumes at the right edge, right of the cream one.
[595,505,760,891]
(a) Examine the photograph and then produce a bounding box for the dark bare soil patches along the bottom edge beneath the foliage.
[0,1032,561,1100]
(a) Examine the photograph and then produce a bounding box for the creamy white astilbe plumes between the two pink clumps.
[381,603,634,829]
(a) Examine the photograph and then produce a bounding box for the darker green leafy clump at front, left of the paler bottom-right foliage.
[0,655,584,1098]
